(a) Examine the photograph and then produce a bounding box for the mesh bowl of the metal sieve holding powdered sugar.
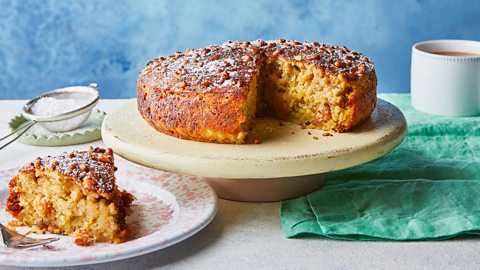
[23,83,99,132]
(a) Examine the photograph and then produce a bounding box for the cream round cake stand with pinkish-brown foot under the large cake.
[102,100,407,201]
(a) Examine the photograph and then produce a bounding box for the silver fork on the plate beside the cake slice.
[0,223,60,249]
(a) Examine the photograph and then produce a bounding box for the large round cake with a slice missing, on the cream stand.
[137,39,377,144]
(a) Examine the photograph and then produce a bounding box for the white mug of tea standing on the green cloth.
[410,40,480,116]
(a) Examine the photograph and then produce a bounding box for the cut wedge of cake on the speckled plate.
[6,147,134,246]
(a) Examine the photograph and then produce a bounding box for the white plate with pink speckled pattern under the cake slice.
[0,157,217,266]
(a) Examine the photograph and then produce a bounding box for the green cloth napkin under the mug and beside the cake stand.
[280,94,480,240]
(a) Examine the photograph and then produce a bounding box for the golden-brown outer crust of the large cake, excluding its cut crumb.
[137,39,376,143]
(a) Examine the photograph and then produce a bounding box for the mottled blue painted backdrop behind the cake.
[0,0,480,99]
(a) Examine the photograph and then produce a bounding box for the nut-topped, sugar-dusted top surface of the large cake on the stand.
[138,39,374,93]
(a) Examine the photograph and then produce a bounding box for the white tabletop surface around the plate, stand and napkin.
[0,100,480,270]
